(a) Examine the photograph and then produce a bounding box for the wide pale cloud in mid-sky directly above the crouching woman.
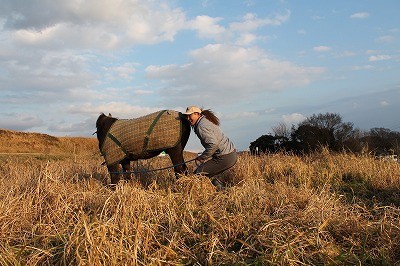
[146,44,324,104]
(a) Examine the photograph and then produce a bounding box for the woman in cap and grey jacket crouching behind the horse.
[184,106,237,190]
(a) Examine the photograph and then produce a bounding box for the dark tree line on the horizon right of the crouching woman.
[249,113,400,155]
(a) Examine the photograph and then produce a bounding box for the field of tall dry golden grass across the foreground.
[0,151,400,265]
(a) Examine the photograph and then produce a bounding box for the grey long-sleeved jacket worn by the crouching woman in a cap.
[193,116,236,160]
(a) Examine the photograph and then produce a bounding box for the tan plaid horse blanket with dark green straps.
[100,110,182,165]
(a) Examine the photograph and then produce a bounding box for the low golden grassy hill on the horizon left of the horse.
[0,129,98,155]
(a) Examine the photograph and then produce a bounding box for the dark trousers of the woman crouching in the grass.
[194,152,237,177]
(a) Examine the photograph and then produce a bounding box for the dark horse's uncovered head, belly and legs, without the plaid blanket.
[96,111,190,185]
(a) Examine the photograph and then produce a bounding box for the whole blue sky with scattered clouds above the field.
[0,0,400,151]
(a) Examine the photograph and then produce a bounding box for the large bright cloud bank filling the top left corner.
[0,0,186,50]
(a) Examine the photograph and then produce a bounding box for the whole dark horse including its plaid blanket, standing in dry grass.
[95,110,190,187]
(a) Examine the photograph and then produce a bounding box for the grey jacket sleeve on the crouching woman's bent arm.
[198,124,221,160]
